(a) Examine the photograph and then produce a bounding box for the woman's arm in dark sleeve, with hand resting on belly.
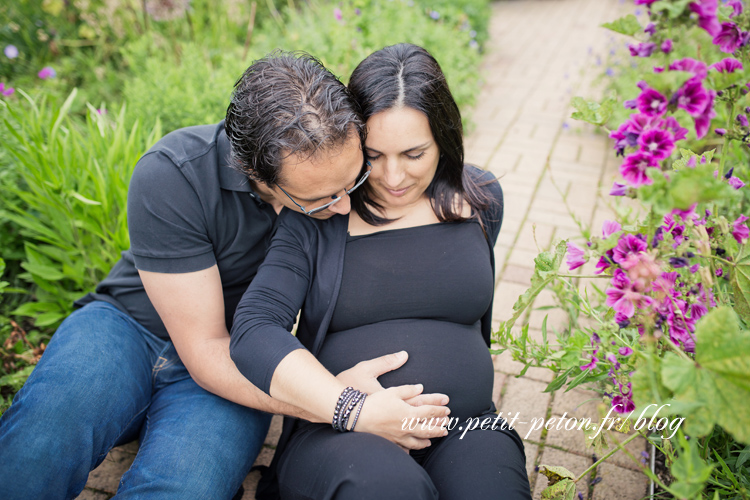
[230,213,449,449]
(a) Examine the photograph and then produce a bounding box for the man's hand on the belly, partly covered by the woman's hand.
[336,351,448,406]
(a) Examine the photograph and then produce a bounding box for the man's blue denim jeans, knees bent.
[0,302,271,500]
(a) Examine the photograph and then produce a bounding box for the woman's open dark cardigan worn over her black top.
[230,166,503,499]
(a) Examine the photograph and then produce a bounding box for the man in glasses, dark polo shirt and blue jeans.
[0,53,446,500]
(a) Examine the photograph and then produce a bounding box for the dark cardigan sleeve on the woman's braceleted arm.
[229,212,311,394]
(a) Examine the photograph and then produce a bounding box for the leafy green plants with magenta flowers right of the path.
[497,0,750,499]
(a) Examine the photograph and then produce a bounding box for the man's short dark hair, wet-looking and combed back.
[224,50,365,185]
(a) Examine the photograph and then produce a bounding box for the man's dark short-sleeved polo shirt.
[75,121,276,339]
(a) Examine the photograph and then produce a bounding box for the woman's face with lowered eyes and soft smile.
[365,107,440,209]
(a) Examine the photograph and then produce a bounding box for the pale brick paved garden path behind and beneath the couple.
[79,0,647,500]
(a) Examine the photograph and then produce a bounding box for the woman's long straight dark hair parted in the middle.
[349,43,492,226]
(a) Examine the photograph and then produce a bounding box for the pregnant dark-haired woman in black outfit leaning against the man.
[232,44,531,500]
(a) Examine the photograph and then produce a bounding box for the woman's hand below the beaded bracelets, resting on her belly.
[355,384,450,450]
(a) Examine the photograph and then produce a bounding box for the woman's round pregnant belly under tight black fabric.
[318,319,494,420]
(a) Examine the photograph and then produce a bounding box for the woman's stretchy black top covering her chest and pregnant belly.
[318,221,494,420]
